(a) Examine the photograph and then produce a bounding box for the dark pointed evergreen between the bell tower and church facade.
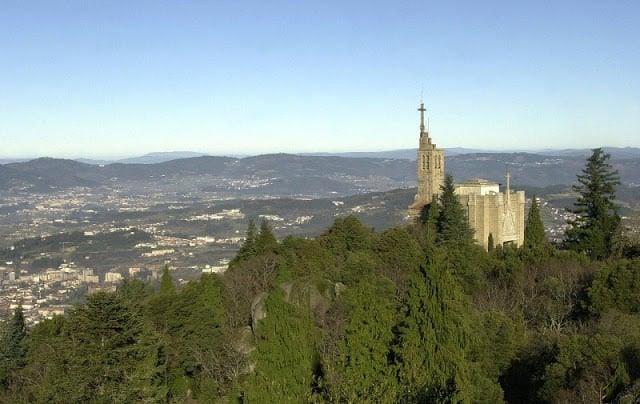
[436,174,474,245]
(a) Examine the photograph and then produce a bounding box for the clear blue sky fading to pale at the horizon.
[0,0,640,158]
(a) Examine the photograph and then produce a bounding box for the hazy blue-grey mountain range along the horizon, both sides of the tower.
[0,148,640,195]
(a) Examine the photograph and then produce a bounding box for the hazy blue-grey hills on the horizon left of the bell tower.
[0,154,415,194]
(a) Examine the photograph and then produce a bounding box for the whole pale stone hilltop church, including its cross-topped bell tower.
[409,104,525,249]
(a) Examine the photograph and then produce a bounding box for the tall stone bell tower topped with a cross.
[410,103,444,216]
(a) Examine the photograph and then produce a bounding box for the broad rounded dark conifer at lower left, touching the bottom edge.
[59,292,166,402]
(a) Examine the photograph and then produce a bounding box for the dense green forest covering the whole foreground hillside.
[0,149,640,403]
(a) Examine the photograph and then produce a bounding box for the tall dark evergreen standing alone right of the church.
[565,148,620,259]
